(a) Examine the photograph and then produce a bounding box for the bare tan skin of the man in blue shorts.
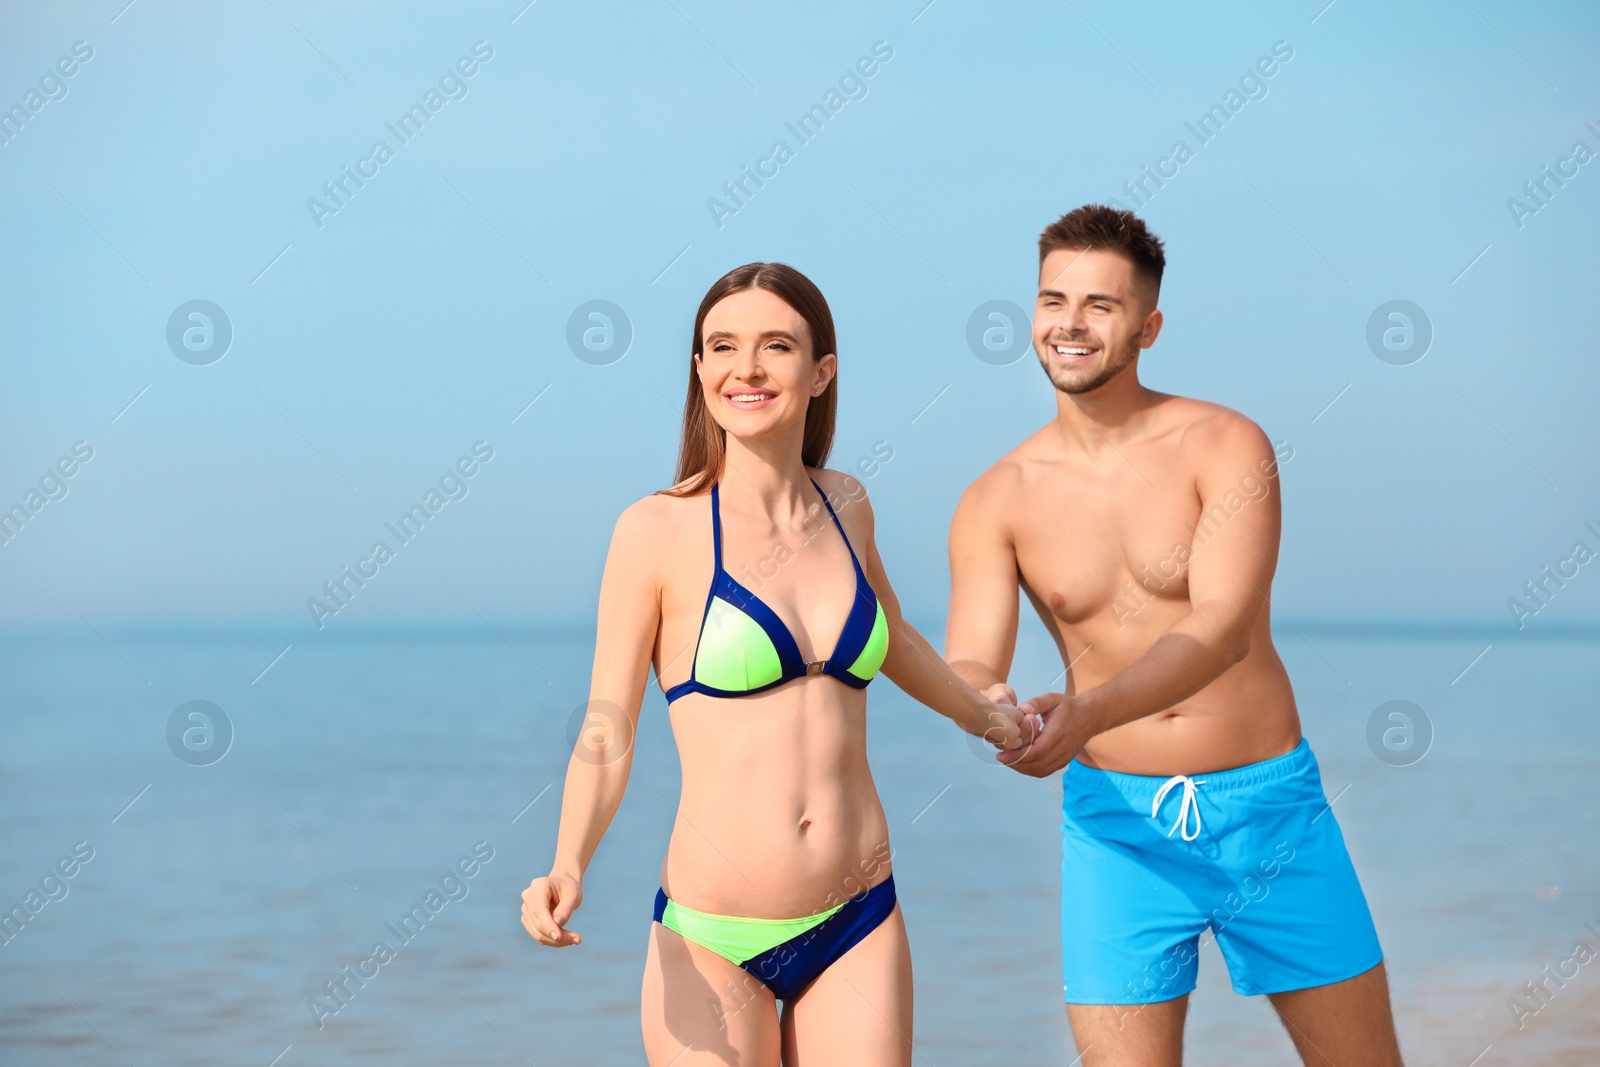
[946,250,1400,1067]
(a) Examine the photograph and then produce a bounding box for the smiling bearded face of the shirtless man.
[1034,248,1162,395]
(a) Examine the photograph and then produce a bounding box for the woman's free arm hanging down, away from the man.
[522,498,666,947]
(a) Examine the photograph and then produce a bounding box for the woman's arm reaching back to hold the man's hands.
[835,475,1032,749]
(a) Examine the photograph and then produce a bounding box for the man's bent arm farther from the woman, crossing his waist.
[1002,416,1283,777]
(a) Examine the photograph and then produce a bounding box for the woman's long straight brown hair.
[662,262,838,496]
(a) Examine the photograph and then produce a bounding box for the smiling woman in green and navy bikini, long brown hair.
[522,262,1034,1067]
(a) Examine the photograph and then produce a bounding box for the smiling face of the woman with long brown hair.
[698,290,838,437]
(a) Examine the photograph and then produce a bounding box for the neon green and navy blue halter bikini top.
[667,480,890,704]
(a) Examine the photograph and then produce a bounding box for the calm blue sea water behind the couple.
[0,625,1600,1067]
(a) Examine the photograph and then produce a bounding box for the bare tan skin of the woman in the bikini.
[522,290,1034,1067]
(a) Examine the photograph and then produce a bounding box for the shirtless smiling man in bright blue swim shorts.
[946,205,1400,1067]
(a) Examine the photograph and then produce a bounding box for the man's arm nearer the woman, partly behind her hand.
[944,467,1018,701]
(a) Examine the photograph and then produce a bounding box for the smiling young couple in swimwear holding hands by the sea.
[522,206,1400,1067]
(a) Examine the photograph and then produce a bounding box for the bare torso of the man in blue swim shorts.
[997,394,1299,774]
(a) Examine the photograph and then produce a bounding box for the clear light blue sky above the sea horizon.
[0,0,1600,633]
